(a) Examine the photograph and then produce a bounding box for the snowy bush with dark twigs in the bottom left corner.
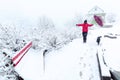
[0,51,23,80]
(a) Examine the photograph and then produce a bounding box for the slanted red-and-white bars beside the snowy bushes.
[12,42,32,66]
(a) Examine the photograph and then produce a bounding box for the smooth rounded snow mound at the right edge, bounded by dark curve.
[102,32,120,71]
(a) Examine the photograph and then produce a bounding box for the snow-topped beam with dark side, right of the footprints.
[97,50,111,80]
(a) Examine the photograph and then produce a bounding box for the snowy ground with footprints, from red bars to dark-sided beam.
[16,31,100,80]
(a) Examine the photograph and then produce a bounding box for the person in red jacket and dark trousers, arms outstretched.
[76,20,93,43]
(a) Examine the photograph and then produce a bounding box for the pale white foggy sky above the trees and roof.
[0,0,120,25]
